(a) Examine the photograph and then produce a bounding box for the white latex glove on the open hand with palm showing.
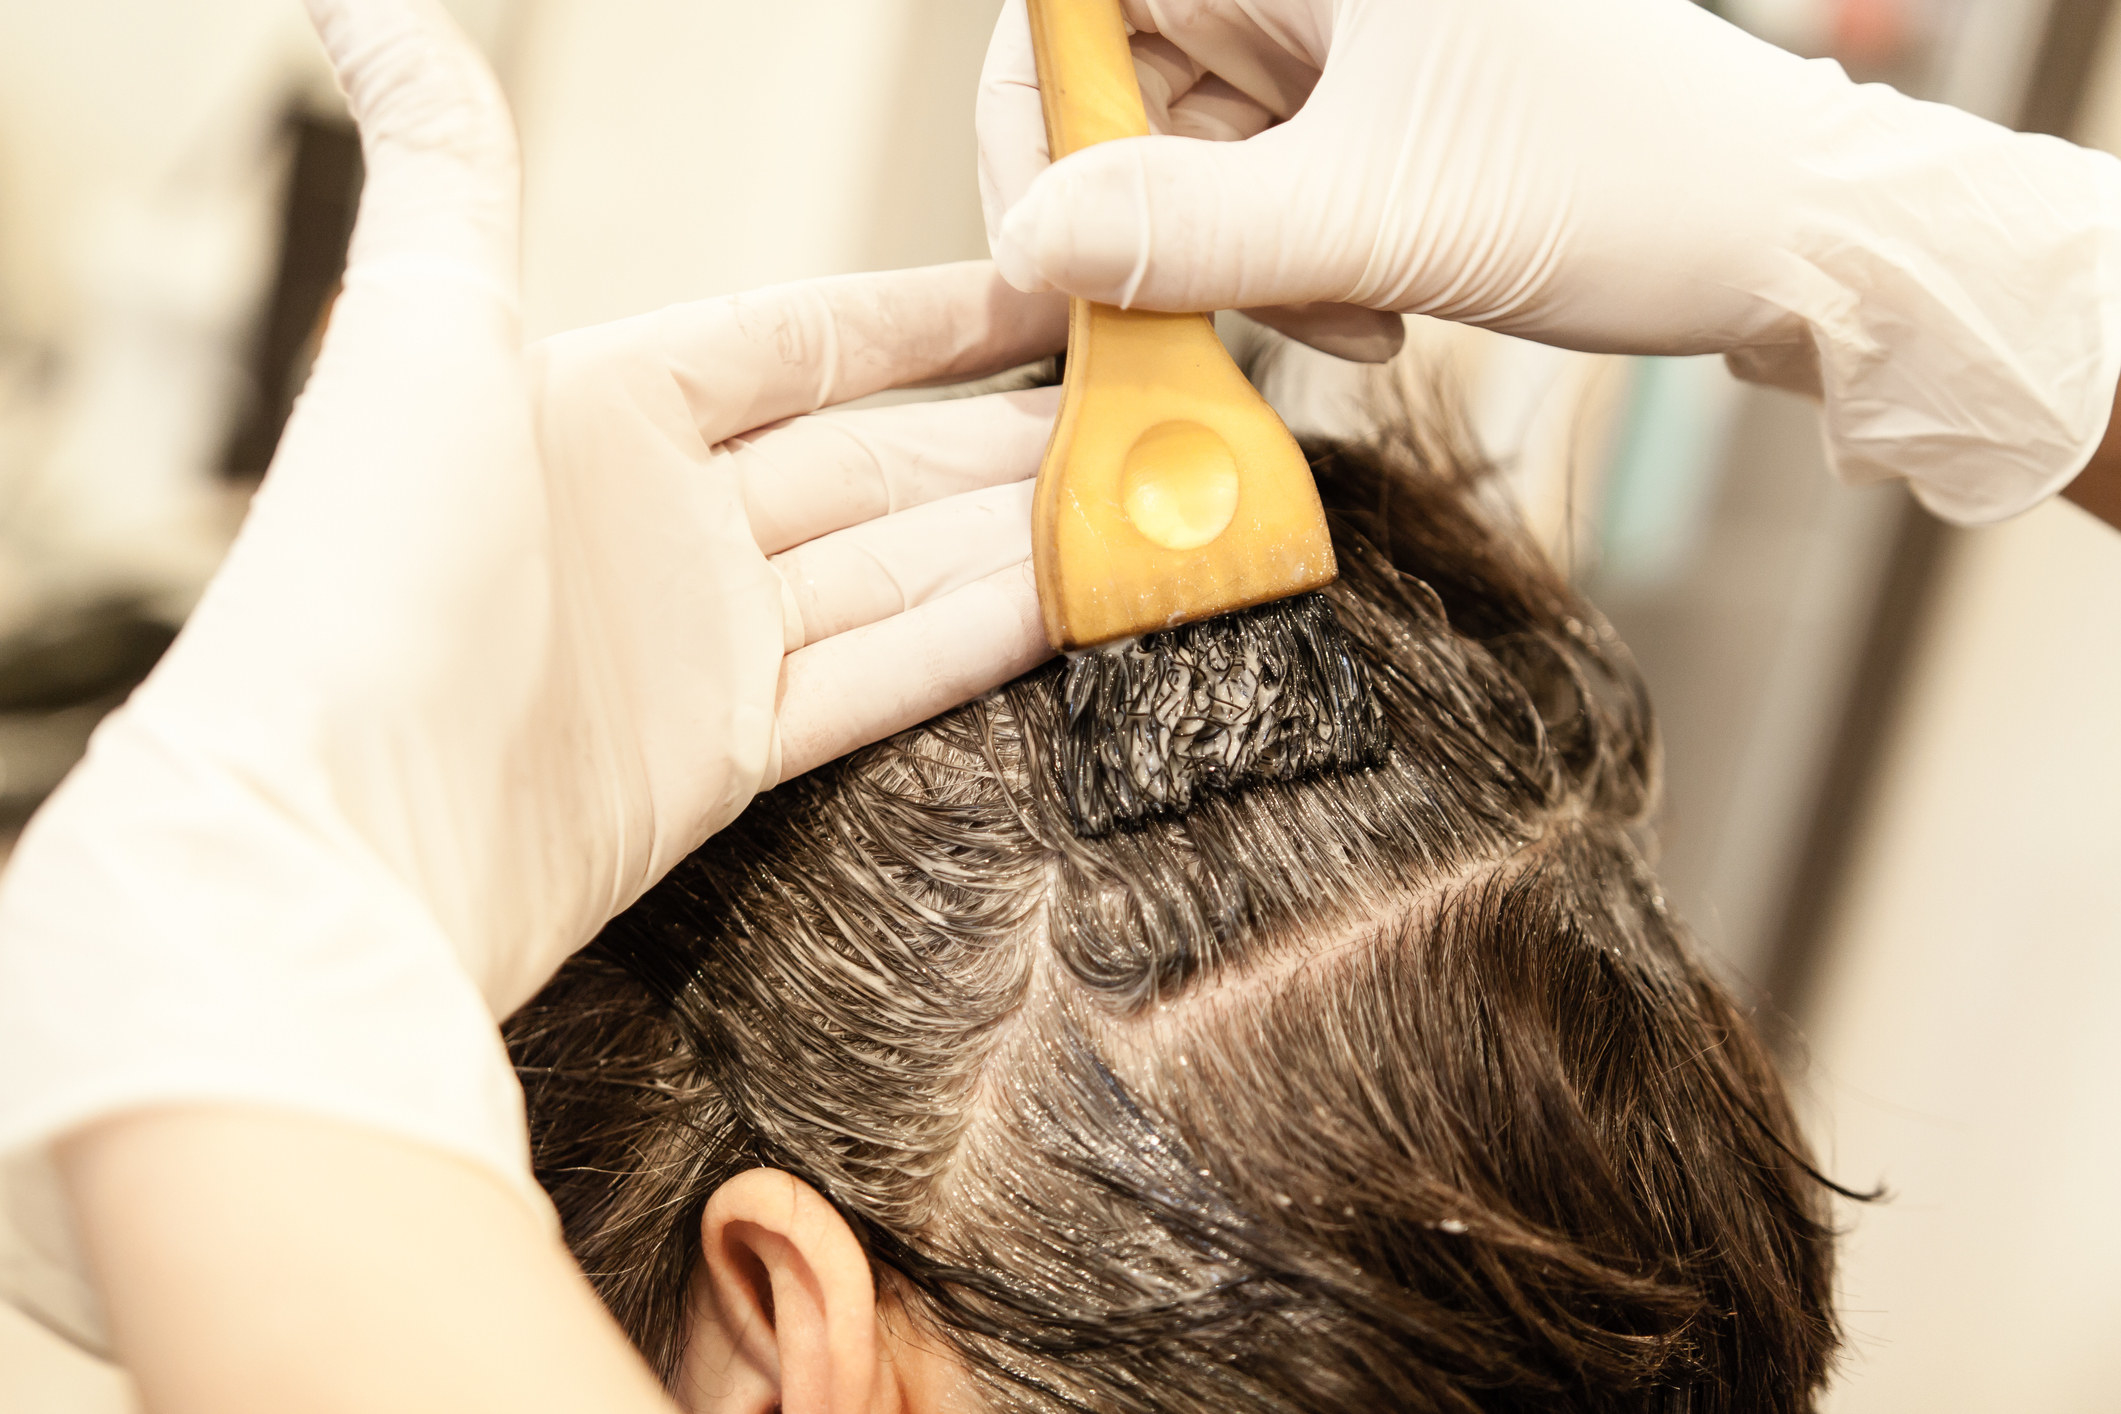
[0,0,1067,1342]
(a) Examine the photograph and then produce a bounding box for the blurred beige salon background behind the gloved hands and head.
[0,0,2121,1414]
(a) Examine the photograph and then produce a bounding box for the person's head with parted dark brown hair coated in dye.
[511,411,1835,1414]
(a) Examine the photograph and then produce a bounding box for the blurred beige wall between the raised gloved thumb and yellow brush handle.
[507,0,1001,335]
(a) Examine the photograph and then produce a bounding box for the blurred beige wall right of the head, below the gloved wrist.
[1807,502,2121,1414]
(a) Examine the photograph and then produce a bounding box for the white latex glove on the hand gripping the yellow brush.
[978,0,2121,522]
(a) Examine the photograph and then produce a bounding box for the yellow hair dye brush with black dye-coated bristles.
[1031,0,1387,835]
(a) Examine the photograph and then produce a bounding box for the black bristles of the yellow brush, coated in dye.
[1061,594,1389,835]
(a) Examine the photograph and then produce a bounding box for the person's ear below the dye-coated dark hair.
[674,1168,899,1414]
